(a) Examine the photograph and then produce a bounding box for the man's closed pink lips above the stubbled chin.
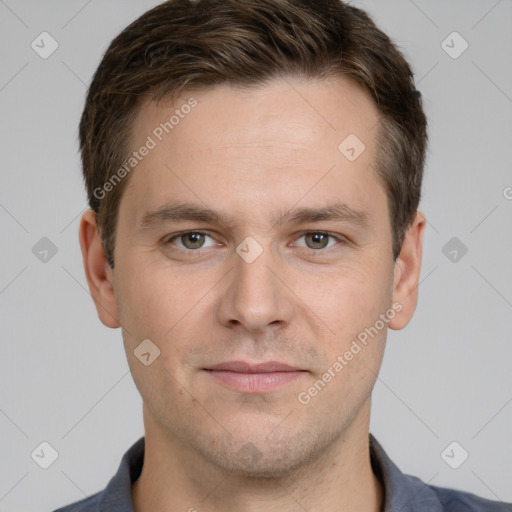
[204,361,308,393]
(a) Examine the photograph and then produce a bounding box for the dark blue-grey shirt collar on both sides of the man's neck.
[97,434,442,512]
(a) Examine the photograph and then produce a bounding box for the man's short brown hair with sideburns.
[79,0,427,268]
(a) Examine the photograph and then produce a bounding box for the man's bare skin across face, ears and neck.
[80,78,425,512]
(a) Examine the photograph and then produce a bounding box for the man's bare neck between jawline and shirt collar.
[132,401,383,512]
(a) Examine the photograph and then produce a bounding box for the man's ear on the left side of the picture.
[79,210,121,329]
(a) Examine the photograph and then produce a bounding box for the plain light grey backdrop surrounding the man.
[0,0,512,512]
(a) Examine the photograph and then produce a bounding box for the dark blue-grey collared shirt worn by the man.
[54,434,512,512]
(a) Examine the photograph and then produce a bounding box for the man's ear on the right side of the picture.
[388,210,426,330]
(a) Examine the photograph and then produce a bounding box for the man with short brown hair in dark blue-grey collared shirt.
[54,0,512,512]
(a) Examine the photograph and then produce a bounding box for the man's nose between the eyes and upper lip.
[218,244,294,334]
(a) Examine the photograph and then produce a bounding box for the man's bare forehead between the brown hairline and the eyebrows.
[120,78,384,226]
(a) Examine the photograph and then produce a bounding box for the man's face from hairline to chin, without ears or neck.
[113,79,400,476]
